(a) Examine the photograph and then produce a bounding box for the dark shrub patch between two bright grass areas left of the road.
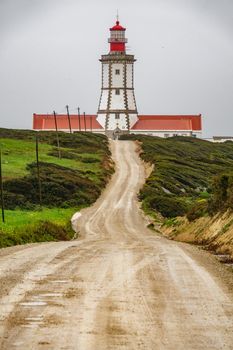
[4,162,104,209]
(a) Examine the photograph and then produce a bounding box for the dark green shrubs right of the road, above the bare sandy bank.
[122,135,233,220]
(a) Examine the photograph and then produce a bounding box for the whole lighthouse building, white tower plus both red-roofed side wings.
[33,18,202,139]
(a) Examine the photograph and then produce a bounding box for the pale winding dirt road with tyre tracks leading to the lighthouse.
[0,141,233,350]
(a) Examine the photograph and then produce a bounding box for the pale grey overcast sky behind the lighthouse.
[0,0,233,137]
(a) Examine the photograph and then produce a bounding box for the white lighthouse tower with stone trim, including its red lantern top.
[97,20,138,137]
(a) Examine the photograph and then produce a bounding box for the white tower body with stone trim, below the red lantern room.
[97,55,137,131]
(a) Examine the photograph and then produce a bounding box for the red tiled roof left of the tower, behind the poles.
[33,114,103,131]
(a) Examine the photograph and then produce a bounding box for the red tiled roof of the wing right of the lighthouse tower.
[131,115,202,131]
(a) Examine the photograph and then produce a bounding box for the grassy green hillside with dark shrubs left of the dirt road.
[0,129,113,247]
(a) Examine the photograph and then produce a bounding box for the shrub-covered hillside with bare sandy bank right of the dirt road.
[120,135,233,257]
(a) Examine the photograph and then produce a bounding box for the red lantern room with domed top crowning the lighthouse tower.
[108,20,128,53]
